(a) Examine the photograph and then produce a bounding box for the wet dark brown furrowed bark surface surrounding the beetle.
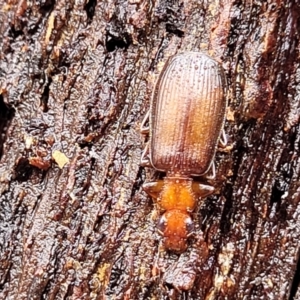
[0,0,300,299]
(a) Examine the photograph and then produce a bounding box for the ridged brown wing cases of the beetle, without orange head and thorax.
[150,52,226,175]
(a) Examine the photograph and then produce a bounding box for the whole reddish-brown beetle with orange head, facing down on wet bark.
[142,52,226,252]
